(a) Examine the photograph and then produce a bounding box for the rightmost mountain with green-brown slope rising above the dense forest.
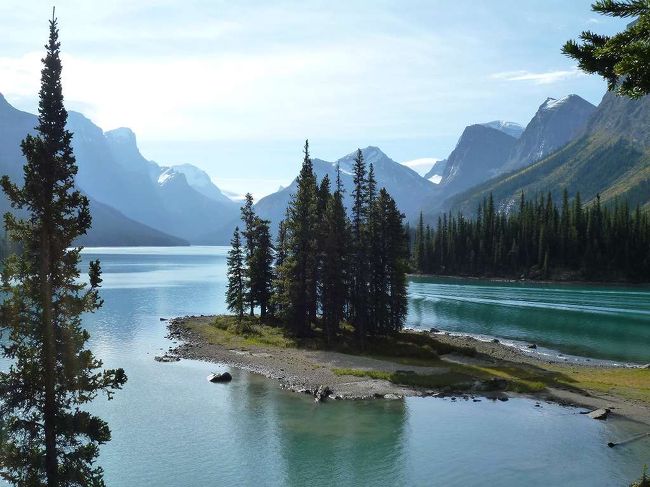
[447,93,650,214]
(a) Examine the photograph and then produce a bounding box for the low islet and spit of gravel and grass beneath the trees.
[162,315,650,425]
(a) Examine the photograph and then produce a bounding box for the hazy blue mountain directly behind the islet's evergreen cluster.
[232,147,436,236]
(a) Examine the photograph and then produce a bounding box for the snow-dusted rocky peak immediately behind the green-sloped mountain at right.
[501,95,596,172]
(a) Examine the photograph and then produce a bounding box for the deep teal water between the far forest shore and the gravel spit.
[408,277,650,364]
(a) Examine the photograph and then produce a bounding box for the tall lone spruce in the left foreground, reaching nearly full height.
[0,15,126,487]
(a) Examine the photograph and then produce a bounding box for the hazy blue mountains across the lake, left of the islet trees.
[0,96,238,245]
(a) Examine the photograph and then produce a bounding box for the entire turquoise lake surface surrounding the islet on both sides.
[0,247,650,487]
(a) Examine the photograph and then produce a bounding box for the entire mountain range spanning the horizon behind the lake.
[0,86,650,245]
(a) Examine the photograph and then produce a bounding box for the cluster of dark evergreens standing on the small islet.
[226,143,409,346]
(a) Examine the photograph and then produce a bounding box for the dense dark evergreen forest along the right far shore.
[412,191,650,281]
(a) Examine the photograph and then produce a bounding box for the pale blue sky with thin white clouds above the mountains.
[0,0,624,196]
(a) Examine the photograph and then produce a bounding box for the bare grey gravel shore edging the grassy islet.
[156,316,650,425]
